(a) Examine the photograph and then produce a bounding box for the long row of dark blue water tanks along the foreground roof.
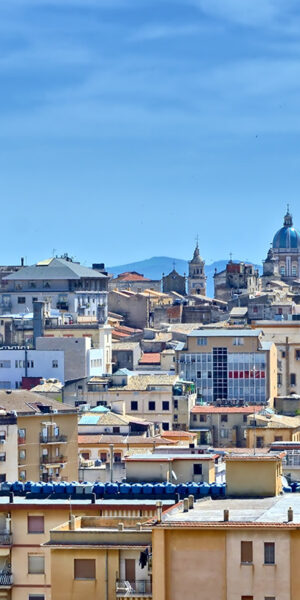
[0,481,226,500]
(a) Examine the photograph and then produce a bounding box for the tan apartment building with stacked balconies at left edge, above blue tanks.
[0,390,78,481]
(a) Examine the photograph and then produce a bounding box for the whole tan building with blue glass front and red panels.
[176,328,277,404]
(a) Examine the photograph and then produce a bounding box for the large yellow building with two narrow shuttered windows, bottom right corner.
[152,494,300,600]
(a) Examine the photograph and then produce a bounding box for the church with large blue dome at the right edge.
[262,208,300,285]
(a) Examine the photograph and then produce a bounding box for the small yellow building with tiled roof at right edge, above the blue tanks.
[246,413,300,448]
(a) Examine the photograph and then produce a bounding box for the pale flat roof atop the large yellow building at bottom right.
[161,494,300,529]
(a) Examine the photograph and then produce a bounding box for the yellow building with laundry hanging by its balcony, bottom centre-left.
[47,517,152,600]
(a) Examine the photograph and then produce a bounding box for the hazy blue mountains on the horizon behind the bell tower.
[107,256,262,296]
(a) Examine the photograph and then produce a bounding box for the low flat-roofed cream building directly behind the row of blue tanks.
[125,450,221,484]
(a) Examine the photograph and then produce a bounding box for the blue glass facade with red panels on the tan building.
[179,347,267,404]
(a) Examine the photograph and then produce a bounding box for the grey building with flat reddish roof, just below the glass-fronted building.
[190,406,262,448]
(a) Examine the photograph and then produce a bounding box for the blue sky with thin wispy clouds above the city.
[0,0,300,265]
